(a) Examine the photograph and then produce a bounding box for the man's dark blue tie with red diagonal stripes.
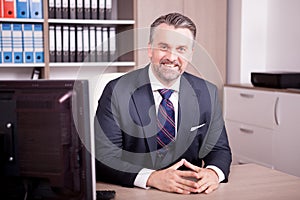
[157,89,175,149]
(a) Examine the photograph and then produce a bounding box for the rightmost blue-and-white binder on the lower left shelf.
[33,24,44,63]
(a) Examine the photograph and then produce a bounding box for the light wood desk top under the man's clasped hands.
[96,164,300,200]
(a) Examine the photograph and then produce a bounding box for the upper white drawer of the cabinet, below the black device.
[224,87,278,128]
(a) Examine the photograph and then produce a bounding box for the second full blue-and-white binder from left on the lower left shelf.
[12,24,23,63]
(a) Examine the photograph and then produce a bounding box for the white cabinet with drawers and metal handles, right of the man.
[224,86,300,176]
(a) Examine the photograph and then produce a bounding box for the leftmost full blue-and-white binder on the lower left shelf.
[2,23,12,63]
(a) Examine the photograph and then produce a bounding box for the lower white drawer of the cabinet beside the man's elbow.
[225,120,273,167]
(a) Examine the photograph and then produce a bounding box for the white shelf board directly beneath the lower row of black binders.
[49,62,135,67]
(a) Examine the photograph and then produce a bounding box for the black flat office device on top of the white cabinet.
[251,72,300,89]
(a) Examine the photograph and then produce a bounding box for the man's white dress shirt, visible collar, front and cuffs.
[134,65,225,189]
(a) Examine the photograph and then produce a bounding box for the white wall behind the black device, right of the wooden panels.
[227,0,300,83]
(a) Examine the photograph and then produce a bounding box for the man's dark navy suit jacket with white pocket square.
[95,66,231,187]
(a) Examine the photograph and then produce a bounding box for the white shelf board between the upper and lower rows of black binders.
[48,19,135,25]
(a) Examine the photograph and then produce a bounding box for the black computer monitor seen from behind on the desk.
[0,80,95,200]
